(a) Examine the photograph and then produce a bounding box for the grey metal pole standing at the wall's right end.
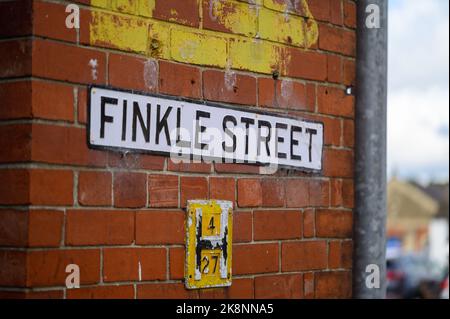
[353,0,388,299]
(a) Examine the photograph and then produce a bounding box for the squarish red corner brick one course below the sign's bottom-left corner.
[29,169,73,206]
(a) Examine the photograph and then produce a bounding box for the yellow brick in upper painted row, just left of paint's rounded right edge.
[259,9,305,46]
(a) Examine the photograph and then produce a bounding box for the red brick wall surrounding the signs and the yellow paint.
[0,0,356,298]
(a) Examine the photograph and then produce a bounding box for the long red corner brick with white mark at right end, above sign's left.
[33,40,106,84]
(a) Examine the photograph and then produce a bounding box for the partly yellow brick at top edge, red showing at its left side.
[204,0,258,37]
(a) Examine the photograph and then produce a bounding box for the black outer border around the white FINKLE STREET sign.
[86,84,325,175]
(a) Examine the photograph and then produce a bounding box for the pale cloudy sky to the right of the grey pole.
[388,0,449,184]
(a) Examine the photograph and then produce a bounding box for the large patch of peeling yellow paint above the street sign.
[89,0,319,74]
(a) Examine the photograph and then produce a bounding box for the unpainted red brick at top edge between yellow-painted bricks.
[153,0,200,28]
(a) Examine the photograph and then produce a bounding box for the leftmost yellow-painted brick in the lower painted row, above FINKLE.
[90,11,148,53]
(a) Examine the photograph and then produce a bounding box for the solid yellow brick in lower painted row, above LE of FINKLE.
[170,29,227,68]
